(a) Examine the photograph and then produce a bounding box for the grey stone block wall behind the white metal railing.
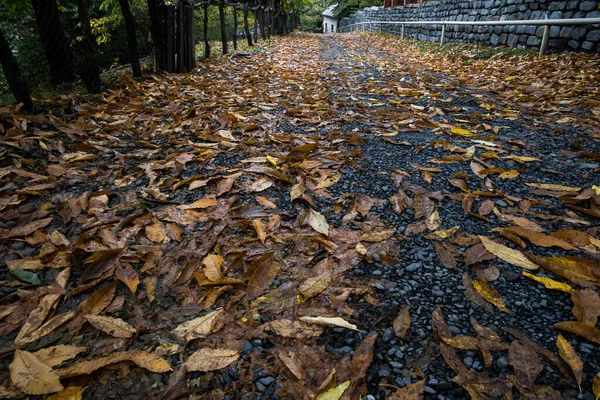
[340,0,600,52]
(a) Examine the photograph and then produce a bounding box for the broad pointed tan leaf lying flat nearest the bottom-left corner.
[8,349,63,394]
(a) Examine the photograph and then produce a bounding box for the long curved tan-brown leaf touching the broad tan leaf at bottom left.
[56,350,171,379]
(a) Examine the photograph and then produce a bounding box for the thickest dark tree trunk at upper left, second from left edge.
[31,0,75,85]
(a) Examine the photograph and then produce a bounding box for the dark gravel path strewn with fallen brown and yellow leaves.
[0,34,600,399]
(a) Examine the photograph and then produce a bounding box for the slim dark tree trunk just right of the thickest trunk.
[77,0,102,93]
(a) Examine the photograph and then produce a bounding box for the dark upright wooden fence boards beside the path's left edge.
[161,3,196,73]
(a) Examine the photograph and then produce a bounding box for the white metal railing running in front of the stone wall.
[338,18,600,56]
